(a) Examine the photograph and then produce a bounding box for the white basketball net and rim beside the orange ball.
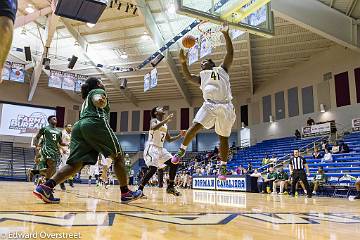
[197,20,223,47]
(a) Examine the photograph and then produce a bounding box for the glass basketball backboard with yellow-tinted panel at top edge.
[177,0,274,38]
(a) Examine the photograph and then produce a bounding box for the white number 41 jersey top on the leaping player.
[200,67,233,102]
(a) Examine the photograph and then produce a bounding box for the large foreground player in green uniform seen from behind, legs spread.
[33,78,142,203]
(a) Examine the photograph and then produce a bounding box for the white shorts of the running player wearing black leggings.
[144,145,173,168]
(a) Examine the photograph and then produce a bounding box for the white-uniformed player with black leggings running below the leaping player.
[139,107,185,196]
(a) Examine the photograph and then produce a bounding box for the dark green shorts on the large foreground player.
[66,118,123,165]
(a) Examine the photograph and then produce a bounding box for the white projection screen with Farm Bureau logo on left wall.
[0,104,56,137]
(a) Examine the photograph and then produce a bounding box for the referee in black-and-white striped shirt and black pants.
[289,149,312,198]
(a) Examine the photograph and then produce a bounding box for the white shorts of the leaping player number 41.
[193,101,236,137]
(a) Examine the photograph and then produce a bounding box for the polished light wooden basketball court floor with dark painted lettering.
[0,182,360,240]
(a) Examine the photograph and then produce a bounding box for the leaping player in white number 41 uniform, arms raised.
[172,26,236,180]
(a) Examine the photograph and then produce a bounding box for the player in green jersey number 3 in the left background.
[34,115,63,179]
